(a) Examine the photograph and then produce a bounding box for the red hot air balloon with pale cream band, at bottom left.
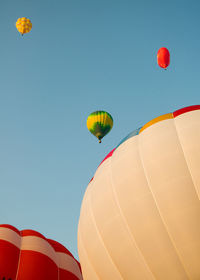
[0,225,82,280]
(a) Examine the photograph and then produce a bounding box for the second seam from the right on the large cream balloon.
[138,123,190,280]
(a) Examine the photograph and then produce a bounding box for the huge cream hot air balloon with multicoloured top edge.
[78,105,200,280]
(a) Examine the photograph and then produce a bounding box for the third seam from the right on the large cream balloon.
[110,138,156,279]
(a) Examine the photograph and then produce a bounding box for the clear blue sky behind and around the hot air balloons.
[0,0,200,257]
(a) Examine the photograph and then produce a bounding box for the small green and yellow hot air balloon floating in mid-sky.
[87,111,113,143]
